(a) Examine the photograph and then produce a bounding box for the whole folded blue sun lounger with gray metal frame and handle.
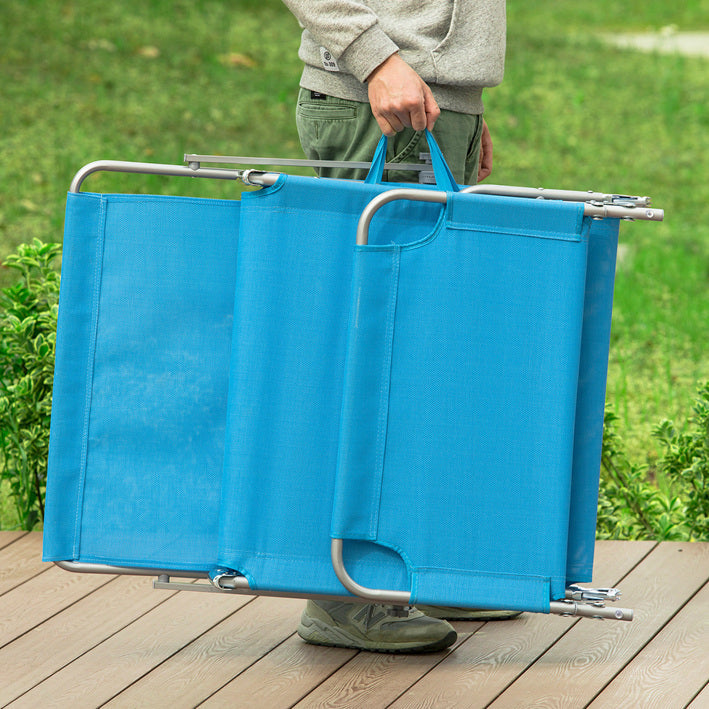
[44,131,662,618]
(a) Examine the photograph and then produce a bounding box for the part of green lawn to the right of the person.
[487,6,709,462]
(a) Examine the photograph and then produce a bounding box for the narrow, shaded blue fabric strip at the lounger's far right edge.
[566,219,619,583]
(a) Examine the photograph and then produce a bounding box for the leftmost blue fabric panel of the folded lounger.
[45,194,240,569]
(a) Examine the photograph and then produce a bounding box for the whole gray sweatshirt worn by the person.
[284,0,505,113]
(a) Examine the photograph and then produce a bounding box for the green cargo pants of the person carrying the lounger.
[296,89,483,185]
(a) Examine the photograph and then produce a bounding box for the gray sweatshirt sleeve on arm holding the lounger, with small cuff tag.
[283,0,399,82]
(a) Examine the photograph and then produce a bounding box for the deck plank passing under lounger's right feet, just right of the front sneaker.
[392,542,655,709]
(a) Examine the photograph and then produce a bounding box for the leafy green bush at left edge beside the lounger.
[0,239,61,529]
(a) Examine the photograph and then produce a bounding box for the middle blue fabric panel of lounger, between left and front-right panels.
[219,176,441,594]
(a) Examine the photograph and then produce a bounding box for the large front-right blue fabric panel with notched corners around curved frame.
[332,195,589,610]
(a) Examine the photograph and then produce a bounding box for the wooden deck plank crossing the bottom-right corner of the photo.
[591,582,709,709]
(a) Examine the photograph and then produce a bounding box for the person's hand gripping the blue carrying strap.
[367,54,441,137]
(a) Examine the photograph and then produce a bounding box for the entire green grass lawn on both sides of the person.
[0,0,709,514]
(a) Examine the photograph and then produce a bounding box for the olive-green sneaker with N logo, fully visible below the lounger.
[298,601,457,653]
